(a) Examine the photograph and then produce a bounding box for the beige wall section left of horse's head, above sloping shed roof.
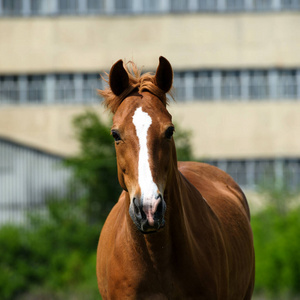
[0,105,108,155]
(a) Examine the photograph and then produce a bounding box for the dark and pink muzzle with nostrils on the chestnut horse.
[129,194,166,233]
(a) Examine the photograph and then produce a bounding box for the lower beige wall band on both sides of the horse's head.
[0,102,300,158]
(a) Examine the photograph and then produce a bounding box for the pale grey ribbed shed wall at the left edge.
[0,139,72,224]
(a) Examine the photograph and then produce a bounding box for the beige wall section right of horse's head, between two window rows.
[171,101,300,158]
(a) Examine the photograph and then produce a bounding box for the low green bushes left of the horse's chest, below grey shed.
[0,200,102,300]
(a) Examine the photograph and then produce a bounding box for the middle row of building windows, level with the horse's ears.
[0,69,300,104]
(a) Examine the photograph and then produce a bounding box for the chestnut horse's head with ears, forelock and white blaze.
[99,57,176,233]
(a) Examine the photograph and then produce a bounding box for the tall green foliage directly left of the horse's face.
[65,111,121,221]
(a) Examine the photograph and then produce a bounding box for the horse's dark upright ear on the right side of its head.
[155,56,173,93]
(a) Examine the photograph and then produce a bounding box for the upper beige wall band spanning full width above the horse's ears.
[0,12,300,74]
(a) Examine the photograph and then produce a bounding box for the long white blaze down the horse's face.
[132,107,158,199]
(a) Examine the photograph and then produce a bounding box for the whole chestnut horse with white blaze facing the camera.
[97,57,254,300]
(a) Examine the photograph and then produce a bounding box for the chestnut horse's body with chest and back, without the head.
[98,163,254,299]
